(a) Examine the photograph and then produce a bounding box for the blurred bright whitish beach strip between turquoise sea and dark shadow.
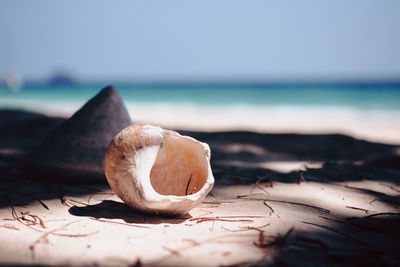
[0,99,400,144]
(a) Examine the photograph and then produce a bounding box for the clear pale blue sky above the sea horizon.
[0,0,400,81]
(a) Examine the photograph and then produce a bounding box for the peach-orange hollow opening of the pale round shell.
[150,133,208,196]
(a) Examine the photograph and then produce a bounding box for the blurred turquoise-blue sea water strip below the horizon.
[0,84,400,111]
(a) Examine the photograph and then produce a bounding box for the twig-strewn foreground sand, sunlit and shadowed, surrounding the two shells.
[0,110,400,266]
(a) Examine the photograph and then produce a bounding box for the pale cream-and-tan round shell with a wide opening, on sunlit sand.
[105,124,214,215]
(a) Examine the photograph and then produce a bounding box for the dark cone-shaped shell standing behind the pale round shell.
[21,86,131,182]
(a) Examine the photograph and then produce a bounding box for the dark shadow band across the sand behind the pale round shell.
[0,110,400,207]
